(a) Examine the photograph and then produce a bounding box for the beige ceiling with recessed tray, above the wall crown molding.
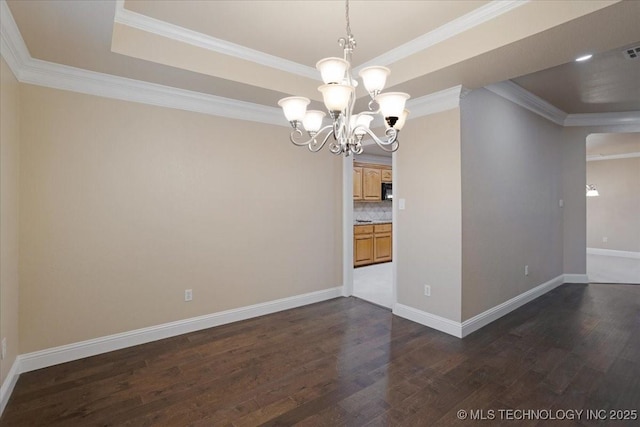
[7,0,640,120]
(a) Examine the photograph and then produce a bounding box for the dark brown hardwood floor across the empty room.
[0,284,640,427]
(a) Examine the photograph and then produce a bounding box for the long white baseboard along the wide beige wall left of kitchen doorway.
[17,286,342,372]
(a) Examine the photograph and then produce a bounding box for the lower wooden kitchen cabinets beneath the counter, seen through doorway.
[353,224,393,267]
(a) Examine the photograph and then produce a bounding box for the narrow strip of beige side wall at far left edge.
[0,59,20,383]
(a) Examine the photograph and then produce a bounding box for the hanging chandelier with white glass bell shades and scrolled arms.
[278,0,409,156]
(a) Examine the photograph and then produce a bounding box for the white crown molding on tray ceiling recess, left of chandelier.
[114,0,320,80]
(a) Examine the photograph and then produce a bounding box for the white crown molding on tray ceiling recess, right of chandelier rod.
[355,0,529,73]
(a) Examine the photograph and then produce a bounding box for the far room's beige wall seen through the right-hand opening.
[587,157,640,252]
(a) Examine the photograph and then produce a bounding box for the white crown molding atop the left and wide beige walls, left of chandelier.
[0,0,289,127]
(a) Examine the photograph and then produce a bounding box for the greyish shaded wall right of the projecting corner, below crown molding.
[461,89,563,321]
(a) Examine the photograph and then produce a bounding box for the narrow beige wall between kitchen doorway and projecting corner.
[394,108,461,321]
